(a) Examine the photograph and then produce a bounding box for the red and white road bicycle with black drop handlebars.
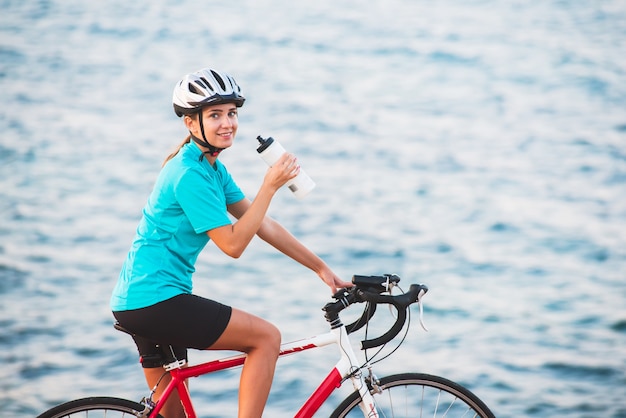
[38,274,495,418]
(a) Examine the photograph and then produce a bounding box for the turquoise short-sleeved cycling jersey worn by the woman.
[110,142,244,311]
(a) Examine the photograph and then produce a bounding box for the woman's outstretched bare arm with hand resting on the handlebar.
[228,198,352,294]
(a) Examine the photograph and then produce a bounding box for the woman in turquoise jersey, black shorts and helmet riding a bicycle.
[110,68,351,418]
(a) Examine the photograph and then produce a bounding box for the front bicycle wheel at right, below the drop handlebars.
[331,373,495,418]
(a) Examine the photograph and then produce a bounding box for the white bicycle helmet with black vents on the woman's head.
[172,68,246,117]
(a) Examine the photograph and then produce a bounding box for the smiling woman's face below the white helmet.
[187,103,239,148]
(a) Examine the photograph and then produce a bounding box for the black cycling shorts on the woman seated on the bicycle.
[113,294,232,368]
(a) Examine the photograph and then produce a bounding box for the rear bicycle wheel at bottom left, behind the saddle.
[37,396,162,418]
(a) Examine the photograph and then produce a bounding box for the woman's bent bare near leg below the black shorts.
[208,308,281,418]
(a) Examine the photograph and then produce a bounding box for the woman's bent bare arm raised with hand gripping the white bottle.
[207,153,300,258]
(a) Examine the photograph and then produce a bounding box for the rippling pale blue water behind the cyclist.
[0,0,626,417]
